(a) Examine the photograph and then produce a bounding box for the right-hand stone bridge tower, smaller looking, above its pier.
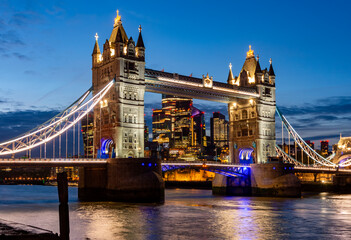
[228,46,276,163]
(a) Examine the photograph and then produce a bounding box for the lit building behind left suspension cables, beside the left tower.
[81,112,94,158]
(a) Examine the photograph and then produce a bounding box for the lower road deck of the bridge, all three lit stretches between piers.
[0,158,351,174]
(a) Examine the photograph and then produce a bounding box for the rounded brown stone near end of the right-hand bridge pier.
[250,163,301,197]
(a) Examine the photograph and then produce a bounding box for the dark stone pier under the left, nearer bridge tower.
[78,158,164,203]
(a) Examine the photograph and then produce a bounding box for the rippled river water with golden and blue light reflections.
[0,185,351,240]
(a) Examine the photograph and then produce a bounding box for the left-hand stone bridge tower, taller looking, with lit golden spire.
[92,11,145,158]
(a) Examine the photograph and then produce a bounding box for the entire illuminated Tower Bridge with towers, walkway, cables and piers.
[0,9,351,201]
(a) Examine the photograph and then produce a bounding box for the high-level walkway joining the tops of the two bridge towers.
[145,69,259,103]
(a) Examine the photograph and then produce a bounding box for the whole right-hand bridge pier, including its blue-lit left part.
[212,163,301,197]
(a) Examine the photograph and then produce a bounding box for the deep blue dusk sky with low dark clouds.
[0,0,351,149]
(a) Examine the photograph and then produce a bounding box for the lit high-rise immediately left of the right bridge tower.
[210,112,229,147]
